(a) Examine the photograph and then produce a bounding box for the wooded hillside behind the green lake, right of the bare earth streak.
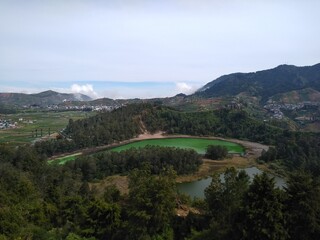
[141,107,282,144]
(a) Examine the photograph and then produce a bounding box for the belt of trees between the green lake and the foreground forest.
[65,146,202,181]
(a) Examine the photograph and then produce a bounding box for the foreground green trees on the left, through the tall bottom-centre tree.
[0,145,176,239]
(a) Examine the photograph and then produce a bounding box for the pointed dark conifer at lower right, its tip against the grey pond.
[242,172,287,240]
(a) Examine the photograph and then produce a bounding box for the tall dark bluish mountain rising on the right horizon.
[194,64,320,102]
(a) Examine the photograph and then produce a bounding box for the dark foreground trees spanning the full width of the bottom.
[0,142,320,240]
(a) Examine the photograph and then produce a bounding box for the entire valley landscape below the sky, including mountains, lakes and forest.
[0,62,320,240]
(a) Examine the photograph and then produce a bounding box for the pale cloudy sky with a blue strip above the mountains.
[0,0,320,99]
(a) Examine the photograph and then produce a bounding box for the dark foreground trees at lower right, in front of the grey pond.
[190,168,320,240]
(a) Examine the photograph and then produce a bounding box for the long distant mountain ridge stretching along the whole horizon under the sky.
[0,63,320,107]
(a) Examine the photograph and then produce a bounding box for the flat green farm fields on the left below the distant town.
[0,111,95,145]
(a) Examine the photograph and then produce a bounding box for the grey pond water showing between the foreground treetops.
[177,167,286,198]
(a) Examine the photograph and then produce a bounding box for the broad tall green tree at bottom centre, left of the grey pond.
[128,166,176,239]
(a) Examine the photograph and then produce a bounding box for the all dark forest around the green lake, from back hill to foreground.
[0,105,320,240]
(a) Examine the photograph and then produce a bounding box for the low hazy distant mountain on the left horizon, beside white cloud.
[0,90,92,107]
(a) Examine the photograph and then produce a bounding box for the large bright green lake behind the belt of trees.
[111,138,244,154]
